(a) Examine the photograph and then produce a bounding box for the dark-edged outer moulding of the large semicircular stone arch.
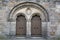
[8,2,49,22]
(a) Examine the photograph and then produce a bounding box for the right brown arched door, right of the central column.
[31,15,42,37]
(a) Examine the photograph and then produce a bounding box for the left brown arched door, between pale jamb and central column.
[16,15,26,36]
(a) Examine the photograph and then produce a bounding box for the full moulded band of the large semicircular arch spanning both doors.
[8,2,49,22]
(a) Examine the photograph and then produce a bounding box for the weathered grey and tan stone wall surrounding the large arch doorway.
[0,0,60,37]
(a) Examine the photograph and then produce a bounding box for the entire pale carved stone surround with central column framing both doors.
[8,2,49,36]
